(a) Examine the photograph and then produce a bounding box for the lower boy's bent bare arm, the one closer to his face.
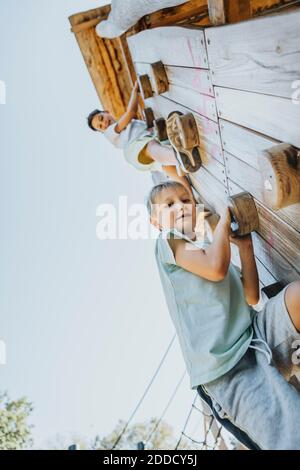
[170,207,231,282]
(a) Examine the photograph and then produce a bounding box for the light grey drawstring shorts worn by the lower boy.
[203,286,300,450]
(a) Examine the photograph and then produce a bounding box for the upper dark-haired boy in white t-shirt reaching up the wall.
[88,82,195,197]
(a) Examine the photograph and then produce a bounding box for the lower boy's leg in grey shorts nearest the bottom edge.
[203,348,300,450]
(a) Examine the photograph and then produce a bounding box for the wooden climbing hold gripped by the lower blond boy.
[227,191,259,236]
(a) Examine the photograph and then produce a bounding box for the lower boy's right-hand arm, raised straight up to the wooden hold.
[230,234,260,305]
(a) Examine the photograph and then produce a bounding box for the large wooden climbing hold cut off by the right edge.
[258,143,300,210]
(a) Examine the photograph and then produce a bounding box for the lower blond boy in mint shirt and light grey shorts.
[147,181,300,450]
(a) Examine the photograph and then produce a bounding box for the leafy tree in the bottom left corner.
[0,392,33,450]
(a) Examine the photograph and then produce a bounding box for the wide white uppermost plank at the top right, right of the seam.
[205,11,300,98]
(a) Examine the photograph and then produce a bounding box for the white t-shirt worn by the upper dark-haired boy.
[103,119,151,149]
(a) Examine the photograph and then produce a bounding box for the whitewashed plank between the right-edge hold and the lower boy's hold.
[224,152,300,232]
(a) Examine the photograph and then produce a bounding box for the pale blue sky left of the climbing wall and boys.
[0,0,194,447]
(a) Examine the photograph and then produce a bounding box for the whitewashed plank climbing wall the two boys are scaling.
[128,10,300,286]
